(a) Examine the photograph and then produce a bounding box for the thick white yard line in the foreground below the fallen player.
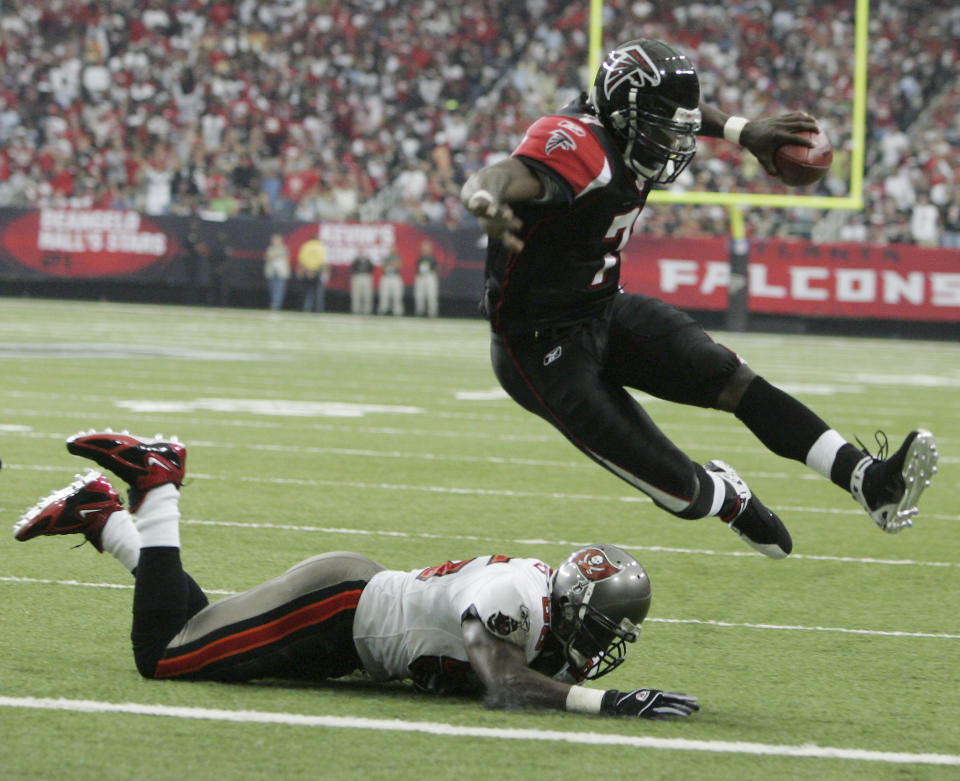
[0,697,960,766]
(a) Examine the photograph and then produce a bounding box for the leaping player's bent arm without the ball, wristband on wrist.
[460,157,543,252]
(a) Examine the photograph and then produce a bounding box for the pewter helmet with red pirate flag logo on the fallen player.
[550,545,650,680]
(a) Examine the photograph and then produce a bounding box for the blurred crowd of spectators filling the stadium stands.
[0,0,960,247]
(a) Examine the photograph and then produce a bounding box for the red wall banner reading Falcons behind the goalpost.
[621,236,960,321]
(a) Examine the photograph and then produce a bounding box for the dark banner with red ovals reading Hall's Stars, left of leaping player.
[0,209,458,298]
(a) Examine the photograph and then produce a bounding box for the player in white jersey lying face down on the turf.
[14,431,698,718]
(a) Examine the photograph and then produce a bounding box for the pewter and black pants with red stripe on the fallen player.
[131,548,383,681]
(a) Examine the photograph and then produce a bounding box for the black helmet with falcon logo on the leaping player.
[588,38,700,184]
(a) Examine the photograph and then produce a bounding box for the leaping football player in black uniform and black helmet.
[461,39,937,558]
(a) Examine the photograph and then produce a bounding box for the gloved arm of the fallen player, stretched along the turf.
[462,618,700,718]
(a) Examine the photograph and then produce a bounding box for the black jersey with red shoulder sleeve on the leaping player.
[484,96,650,333]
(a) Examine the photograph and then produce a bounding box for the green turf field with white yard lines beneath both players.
[0,299,960,781]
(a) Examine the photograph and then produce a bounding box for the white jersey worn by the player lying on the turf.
[353,556,551,681]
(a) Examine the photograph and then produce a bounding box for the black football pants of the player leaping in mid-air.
[491,294,741,517]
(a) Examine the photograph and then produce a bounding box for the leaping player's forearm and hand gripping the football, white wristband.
[700,103,820,176]
